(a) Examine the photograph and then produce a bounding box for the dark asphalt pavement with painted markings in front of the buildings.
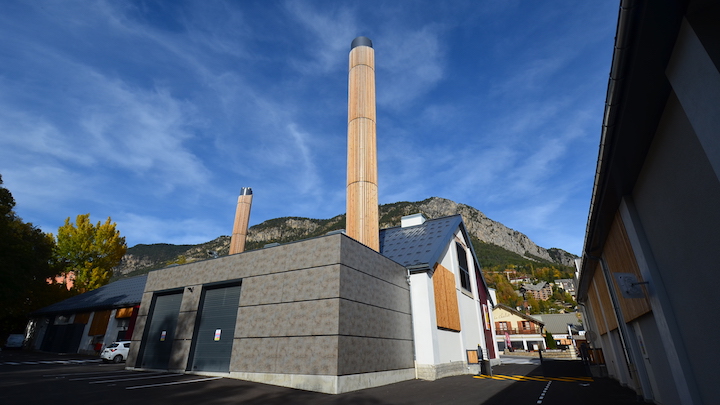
[0,351,637,405]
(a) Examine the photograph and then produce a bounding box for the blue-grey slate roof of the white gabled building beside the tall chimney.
[380,215,462,269]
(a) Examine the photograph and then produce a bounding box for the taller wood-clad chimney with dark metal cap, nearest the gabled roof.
[345,37,380,251]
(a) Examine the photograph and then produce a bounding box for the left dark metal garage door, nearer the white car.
[140,293,182,370]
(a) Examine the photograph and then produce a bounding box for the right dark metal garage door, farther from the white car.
[190,285,240,372]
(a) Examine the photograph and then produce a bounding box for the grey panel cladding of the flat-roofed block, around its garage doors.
[128,234,413,392]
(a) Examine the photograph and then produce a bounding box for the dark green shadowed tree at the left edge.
[0,176,69,341]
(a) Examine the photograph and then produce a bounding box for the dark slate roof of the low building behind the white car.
[31,274,147,315]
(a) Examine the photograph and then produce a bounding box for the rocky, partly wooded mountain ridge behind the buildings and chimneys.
[115,197,577,279]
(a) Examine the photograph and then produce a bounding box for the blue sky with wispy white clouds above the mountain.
[0,0,618,254]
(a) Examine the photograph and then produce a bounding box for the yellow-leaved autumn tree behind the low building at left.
[55,214,127,293]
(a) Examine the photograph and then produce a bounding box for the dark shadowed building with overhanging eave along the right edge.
[577,0,720,404]
